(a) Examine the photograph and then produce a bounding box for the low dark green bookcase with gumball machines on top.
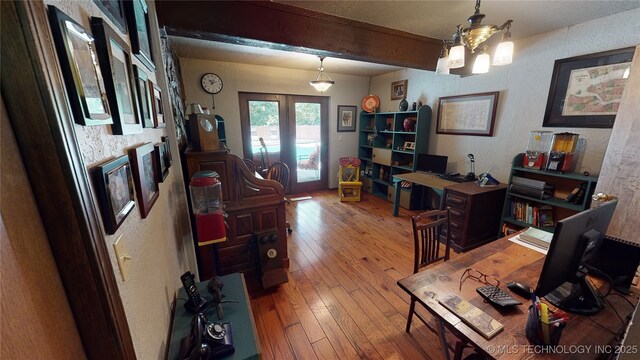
[500,154,598,234]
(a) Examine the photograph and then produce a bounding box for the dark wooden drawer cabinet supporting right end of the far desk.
[442,182,507,252]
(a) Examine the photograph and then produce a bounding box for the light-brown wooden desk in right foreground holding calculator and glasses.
[398,238,638,360]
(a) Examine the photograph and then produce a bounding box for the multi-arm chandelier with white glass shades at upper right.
[436,0,513,74]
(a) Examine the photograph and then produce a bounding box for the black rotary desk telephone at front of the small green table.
[179,313,235,360]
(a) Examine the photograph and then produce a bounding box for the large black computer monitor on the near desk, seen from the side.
[536,200,617,315]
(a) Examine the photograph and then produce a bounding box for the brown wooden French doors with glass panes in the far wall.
[238,92,329,193]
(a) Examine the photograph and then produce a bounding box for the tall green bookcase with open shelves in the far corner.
[358,105,431,209]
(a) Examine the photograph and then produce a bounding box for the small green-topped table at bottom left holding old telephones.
[168,273,261,360]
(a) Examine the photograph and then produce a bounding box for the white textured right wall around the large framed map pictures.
[371,9,640,181]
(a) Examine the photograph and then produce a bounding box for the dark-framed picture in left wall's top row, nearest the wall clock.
[124,0,156,71]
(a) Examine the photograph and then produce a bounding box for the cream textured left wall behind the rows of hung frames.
[46,1,197,359]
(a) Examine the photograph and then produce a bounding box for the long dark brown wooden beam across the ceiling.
[156,1,442,71]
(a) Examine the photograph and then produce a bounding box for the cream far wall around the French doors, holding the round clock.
[180,58,369,188]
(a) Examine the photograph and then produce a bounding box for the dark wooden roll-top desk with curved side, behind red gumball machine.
[182,149,289,279]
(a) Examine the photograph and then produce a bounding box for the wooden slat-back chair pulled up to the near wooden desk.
[405,209,462,359]
